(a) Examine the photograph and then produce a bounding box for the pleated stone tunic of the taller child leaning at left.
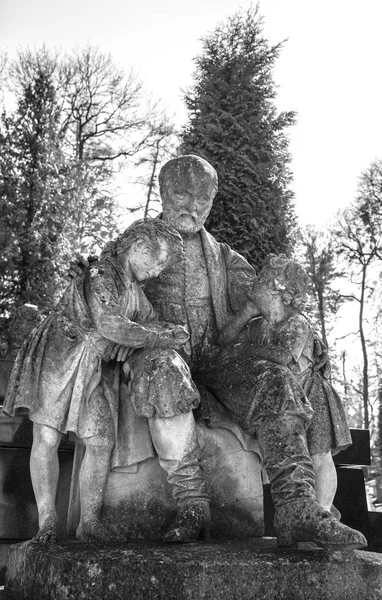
[4,259,169,437]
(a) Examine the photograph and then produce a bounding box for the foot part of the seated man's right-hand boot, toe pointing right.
[274,500,367,550]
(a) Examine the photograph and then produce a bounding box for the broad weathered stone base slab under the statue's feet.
[6,538,382,600]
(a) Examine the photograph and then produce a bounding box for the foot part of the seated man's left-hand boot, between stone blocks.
[162,502,211,544]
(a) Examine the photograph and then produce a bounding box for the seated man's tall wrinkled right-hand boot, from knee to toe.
[256,413,367,549]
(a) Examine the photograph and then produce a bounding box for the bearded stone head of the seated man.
[159,154,218,234]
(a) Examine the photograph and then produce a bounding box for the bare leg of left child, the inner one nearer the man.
[77,435,117,541]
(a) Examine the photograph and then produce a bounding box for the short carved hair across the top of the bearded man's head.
[158,154,218,195]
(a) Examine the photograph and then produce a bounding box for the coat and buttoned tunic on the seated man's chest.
[145,229,255,368]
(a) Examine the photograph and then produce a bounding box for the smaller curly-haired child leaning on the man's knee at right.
[219,254,352,514]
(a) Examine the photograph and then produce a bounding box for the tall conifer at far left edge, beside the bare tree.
[0,72,66,310]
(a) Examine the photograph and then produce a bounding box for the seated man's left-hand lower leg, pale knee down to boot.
[149,412,211,543]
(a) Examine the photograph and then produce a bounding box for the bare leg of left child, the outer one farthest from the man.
[30,423,61,544]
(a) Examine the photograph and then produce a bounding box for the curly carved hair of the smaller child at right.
[258,254,309,309]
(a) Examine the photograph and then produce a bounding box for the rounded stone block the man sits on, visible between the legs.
[68,425,264,540]
